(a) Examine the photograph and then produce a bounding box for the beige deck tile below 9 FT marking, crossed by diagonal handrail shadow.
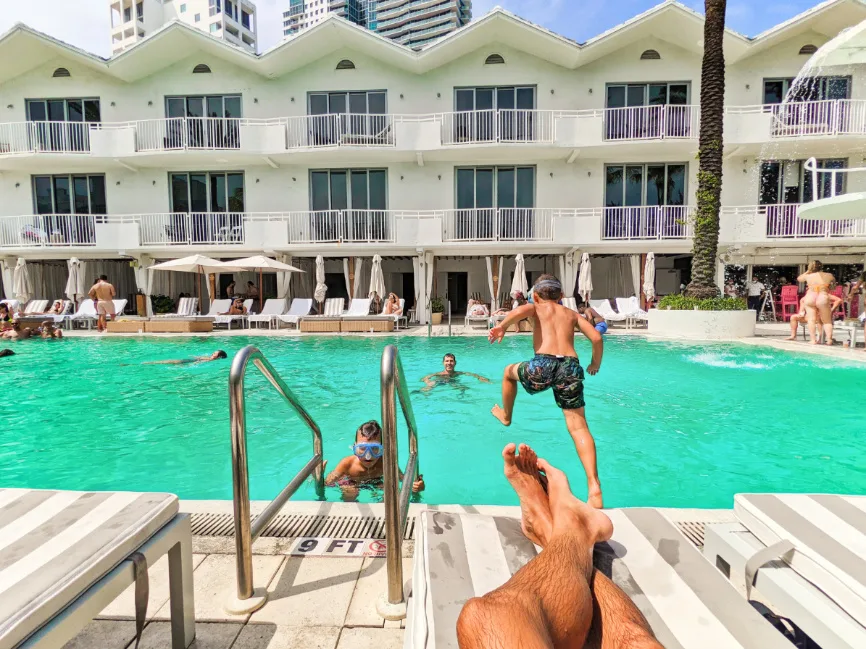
[250,557,363,627]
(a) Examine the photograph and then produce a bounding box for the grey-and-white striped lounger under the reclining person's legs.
[404,509,794,649]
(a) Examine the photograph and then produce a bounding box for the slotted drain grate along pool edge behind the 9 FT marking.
[192,514,415,540]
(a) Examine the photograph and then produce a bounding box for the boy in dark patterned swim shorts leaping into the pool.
[488,275,604,509]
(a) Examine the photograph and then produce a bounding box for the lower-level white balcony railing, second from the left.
[138,212,245,246]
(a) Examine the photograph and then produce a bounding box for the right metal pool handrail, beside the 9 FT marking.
[379,345,418,619]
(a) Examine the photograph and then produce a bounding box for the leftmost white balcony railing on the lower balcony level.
[0,214,98,248]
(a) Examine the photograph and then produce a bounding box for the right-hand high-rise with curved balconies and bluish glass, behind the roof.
[283,0,472,49]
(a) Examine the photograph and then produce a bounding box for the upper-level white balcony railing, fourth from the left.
[440,109,556,145]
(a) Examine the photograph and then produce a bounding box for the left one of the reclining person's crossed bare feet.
[502,444,553,547]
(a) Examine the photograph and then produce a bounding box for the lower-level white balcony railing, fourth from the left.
[442,207,562,241]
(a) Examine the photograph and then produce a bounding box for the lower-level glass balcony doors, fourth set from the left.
[452,166,535,240]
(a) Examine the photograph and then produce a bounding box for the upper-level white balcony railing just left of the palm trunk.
[604,104,700,140]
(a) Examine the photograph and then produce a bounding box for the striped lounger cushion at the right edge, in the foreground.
[734,494,866,626]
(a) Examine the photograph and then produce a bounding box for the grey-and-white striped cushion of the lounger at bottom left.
[0,489,178,647]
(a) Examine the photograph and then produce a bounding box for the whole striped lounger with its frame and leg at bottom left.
[0,489,195,649]
